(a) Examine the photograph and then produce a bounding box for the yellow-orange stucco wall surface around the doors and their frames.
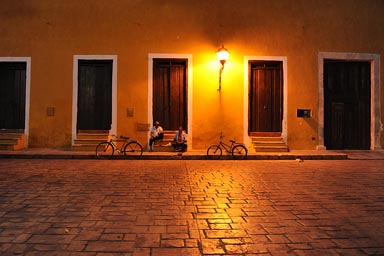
[0,0,384,149]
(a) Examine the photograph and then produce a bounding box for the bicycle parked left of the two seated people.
[96,135,143,159]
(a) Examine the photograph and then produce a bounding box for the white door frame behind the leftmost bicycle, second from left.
[72,55,117,145]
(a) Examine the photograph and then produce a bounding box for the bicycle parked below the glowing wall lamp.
[207,133,248,160]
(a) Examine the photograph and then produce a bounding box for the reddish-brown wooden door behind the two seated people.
[152,59,188,130]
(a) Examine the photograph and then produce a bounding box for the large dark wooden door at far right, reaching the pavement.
[324,60,371,150]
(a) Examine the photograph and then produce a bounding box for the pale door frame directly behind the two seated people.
[148,53,193,149]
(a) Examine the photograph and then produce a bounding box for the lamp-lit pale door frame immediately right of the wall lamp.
[243,56,288,145]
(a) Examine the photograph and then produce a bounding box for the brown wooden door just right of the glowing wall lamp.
[248,61,283,133]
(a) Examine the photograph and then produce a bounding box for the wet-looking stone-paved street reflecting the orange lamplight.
[0,159,384,256]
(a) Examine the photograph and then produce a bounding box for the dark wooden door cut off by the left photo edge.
[0,62,26,130]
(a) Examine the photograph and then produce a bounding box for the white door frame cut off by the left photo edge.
[0,57,31,148]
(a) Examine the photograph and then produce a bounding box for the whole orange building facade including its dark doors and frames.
[0,0,384,150]
